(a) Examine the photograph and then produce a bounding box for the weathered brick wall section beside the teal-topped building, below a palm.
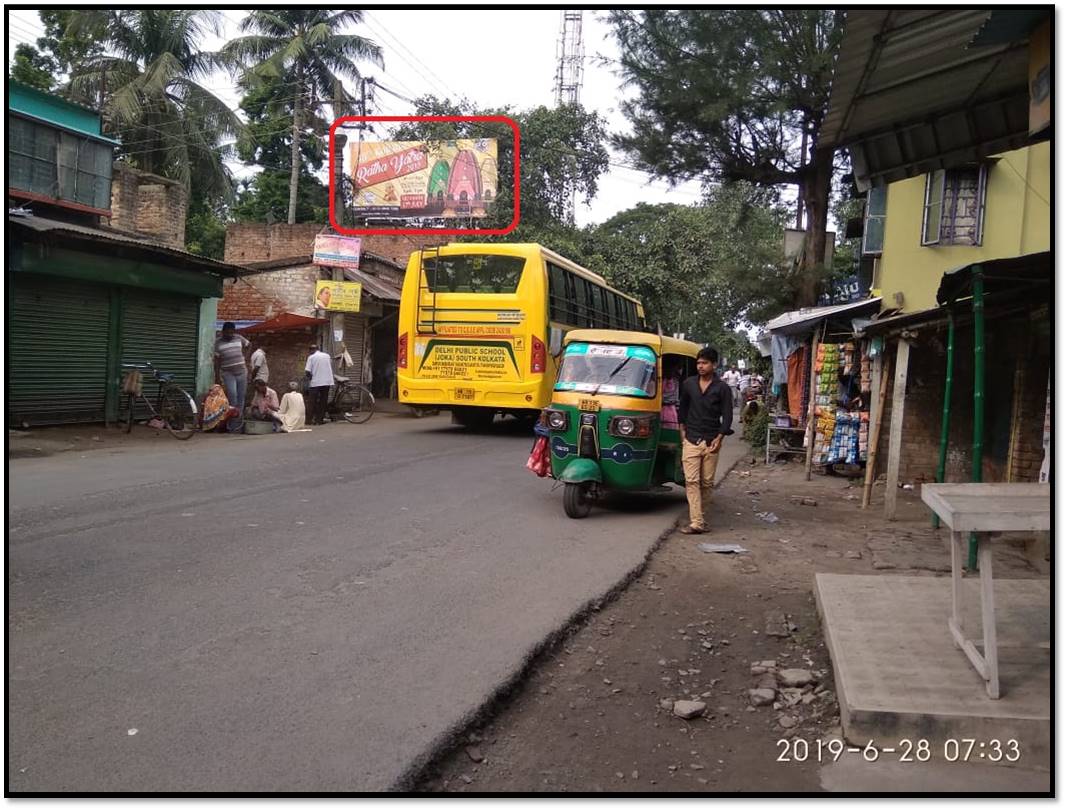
[110,162,189,249]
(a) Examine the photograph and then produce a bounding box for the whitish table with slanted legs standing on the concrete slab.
[922,484,1051,698]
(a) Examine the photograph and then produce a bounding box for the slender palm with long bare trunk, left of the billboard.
[222,7,383,225]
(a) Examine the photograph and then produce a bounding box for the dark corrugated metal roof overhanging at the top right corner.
[822,7,1029,190]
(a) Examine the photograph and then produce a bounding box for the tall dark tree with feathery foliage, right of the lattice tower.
[610,9,843,305]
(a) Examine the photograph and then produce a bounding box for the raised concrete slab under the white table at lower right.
[814,573,1051,767]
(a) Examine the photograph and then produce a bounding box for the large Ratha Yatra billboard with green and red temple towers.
[348,137,499,218]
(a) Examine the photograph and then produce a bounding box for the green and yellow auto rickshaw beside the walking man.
[539,329,699,518]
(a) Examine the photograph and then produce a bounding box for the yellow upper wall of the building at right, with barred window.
[865,142,1051,312]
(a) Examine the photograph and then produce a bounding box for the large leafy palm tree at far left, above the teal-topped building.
[68,9,243,199]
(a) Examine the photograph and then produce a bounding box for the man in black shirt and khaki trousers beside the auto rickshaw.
[678,346,732,534]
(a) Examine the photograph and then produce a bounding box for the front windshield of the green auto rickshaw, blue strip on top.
[555,343,658,399]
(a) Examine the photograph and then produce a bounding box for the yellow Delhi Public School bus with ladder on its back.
[397,243,645,427]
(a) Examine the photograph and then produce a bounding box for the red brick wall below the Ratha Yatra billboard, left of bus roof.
[225,223,450,266]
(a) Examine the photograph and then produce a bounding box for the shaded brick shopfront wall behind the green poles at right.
[876,304,1050,483]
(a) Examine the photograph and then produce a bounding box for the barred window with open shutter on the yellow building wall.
[922,165,987,246]
